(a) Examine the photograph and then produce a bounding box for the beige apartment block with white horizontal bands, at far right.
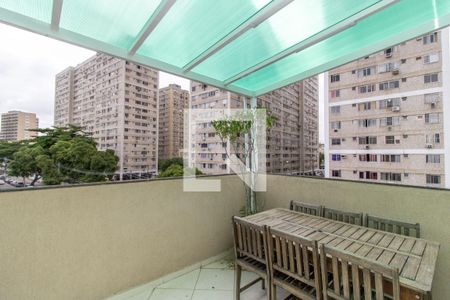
[325,29,450,188]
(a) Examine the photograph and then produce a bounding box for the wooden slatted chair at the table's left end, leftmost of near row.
[233,217,270,300]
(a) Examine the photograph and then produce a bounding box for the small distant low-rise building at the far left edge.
[0,110,39,141]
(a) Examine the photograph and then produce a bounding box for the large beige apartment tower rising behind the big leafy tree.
[54,53,159,178]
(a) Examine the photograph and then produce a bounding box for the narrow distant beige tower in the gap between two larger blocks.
[158,84,189,160]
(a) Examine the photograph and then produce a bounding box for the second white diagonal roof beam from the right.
[183,0,294,72]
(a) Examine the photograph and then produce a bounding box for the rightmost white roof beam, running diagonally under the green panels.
[224,0,400,86]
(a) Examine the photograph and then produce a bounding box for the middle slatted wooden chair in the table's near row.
[267,227,322,300]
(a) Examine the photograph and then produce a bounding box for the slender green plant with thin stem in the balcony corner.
[212,109,276,215]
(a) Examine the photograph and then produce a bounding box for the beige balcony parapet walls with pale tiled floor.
[0,175,450,300]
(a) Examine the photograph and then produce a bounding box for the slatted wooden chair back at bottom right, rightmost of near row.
[320,244,400,300]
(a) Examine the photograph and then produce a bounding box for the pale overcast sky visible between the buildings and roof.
[0,24,323,142]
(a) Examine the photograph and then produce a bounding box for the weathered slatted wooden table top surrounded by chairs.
[246,208,439,292]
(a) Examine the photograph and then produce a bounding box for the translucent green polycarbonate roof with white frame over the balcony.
[0,0,450,96]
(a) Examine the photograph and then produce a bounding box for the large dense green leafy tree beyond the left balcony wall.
[4,126,119,185]
